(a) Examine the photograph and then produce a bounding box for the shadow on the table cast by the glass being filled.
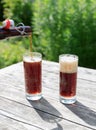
[28,98,63,130]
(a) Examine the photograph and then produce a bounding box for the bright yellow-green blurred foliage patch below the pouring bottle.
[0,39,26,68]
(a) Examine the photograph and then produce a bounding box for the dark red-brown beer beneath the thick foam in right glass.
[60,72,77,97]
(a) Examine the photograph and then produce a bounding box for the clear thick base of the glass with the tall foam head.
[60,96,76,104]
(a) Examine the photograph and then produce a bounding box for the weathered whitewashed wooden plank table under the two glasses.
[0,61,96,130]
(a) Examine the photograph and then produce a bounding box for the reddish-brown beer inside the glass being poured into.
[24,61,41,94]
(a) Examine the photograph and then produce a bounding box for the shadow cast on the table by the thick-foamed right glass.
[65,101,96,126]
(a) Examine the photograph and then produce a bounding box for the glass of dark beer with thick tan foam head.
[59,54,78,104]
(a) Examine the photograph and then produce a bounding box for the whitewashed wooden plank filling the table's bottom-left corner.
[0,112,41,130]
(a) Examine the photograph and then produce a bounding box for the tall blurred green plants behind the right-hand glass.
[34,0,96,68]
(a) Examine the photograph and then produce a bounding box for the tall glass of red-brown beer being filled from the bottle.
[23,52,42,100]
